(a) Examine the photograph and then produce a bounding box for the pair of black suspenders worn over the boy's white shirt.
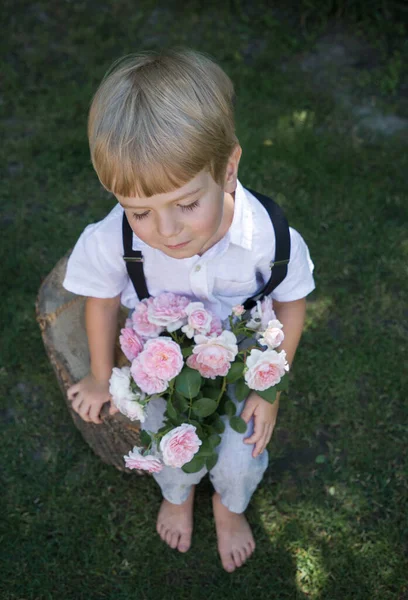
[122,189,290,310]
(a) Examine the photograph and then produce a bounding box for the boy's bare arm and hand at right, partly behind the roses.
[241,298,306,458]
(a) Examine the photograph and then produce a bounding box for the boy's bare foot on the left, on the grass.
[156,486,195,552]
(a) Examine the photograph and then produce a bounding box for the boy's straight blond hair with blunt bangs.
[88,49,238,197]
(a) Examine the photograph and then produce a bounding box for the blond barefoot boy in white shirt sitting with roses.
[64,51,314,572]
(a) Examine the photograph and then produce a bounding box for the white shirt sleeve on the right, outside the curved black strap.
[271,227,316,302]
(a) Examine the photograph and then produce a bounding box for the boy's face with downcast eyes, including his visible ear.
[116,146,241,258]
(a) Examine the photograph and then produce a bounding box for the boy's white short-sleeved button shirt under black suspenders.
[63,182,315,319]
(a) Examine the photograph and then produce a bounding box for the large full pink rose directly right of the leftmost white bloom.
[139,337,183,381]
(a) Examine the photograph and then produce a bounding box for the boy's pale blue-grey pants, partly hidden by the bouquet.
[142,385,268,513]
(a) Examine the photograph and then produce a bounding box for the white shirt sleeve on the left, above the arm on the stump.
[63,222,128,298]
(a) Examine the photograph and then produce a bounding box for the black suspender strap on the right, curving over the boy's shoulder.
[244,189,290,310]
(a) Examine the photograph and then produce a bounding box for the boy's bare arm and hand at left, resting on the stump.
[68,295,120,423]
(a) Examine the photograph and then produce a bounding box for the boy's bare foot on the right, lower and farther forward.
[213,493,255,573]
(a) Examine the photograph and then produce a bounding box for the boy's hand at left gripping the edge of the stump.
[67,373,118,424]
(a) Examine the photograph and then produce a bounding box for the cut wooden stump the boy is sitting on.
[36,253,146,475]
